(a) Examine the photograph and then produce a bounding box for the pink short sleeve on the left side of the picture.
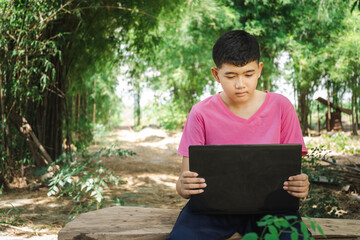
[178,106,205,157]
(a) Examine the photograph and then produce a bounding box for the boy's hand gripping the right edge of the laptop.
[283,173,310,198]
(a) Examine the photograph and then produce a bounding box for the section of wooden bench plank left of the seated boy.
[59,207,179,240]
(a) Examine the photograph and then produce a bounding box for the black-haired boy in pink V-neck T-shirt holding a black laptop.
[169,30,309,240]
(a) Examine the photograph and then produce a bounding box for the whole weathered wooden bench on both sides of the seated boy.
[58,207,360,240]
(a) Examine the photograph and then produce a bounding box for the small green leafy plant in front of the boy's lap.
[242,215,325,240]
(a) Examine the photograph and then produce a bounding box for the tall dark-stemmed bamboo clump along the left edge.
[0,0,176,187]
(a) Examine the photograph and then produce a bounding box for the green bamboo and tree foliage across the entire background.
[0,0,360,219]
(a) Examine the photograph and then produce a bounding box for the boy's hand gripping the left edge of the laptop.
[178,171,206,198]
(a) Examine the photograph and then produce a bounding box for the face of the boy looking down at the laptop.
[211,61,264,104]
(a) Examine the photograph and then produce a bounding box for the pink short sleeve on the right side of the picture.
[280,99,307,156]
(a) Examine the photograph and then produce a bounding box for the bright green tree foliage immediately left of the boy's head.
[151,0,242,114]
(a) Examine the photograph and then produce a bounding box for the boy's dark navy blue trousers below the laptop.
[167,202,311,240]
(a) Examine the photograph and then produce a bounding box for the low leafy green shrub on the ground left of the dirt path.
[48,148,135,212]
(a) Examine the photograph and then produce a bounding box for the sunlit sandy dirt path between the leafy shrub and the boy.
[91,128,186,208]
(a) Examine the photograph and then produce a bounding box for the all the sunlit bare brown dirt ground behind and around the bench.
[0,127,360,240]
